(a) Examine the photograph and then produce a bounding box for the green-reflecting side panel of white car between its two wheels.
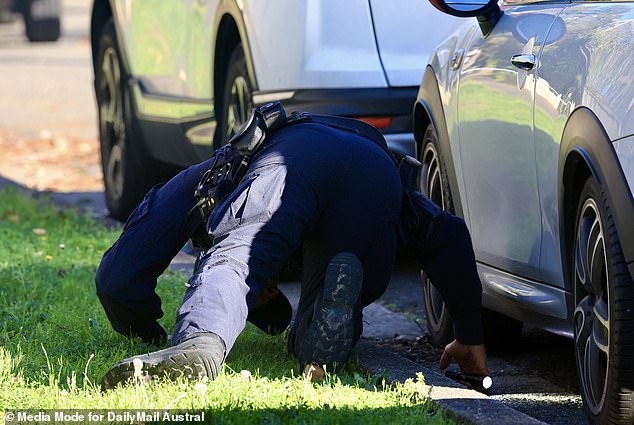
[114,0,218,127]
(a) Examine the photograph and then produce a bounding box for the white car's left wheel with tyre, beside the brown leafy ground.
[95,19,149,221]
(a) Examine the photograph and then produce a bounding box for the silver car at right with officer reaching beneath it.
[414,0,634,425]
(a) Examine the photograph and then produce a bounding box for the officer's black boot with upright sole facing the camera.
[289,252,363,370]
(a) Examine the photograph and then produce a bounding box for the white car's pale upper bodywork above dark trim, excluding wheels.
[103,0,457,115]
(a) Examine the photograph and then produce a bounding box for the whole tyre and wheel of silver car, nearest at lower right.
[572,178,634,425]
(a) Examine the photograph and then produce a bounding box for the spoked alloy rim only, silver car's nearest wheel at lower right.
[574,198,610,415]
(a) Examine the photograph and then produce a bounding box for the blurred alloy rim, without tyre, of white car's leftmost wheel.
[99,47,126,199]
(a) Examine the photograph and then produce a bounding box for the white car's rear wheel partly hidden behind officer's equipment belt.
[215,44,253,147]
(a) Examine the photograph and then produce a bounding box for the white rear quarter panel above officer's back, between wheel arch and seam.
[244,0,387,91]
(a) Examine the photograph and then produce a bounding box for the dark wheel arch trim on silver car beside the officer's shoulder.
[413,65,464,218]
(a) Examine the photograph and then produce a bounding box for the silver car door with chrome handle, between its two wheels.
[458,5,554,279]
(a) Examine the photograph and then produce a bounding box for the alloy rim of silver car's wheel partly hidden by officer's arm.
[419,143,447,332]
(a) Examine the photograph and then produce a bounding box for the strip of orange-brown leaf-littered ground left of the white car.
[0,132,103,192]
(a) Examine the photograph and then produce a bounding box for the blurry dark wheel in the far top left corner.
[23,0,61,42]
